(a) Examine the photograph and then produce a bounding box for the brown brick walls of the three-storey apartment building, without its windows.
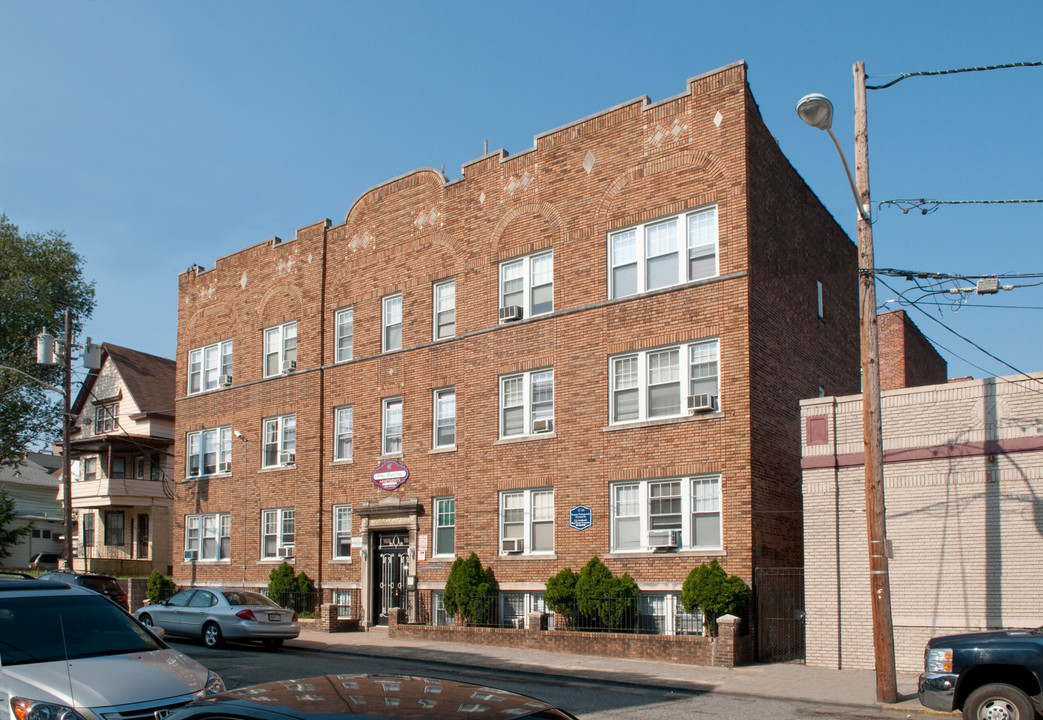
[174,64,858,619]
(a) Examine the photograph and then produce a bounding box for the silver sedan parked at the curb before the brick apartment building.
[135,587,300,648]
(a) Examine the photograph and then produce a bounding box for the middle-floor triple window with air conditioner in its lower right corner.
[609,340,720,423]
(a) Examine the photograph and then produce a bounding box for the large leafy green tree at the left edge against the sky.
[0,214,94,465]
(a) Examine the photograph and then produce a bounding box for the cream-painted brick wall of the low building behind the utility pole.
[801,375,1043,671]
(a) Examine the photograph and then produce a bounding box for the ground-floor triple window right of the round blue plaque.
[611,475,722,552]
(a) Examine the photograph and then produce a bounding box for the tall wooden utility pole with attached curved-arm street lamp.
[797,62,898,702]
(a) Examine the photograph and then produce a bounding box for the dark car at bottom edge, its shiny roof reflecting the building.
[164,675,576,720]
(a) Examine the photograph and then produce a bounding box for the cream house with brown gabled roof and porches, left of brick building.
[58,343,174,575]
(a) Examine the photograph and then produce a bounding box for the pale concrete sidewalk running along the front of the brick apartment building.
[290,627,934,717]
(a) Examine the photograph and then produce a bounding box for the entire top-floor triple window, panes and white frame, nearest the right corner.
[608,206,718,297]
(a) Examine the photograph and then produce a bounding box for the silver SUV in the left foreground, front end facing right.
[0,575,224,720]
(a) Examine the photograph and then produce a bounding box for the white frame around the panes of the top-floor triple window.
[608,205,721,298]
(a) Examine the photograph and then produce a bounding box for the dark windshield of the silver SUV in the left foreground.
[0,595,164,666]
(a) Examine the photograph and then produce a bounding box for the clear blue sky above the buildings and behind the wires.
[0,0,1043,377]
